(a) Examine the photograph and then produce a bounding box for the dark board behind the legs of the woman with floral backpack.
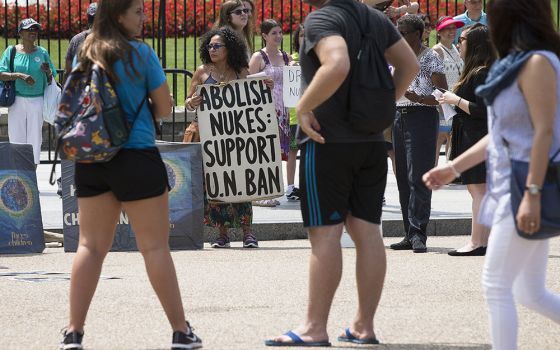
[62,142,204,252]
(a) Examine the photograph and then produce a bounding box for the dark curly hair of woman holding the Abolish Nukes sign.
[200,26,249,73]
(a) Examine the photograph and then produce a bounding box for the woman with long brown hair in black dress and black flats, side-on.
[439,23,496,256]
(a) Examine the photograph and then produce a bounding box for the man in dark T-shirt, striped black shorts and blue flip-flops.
[265,0,418,346]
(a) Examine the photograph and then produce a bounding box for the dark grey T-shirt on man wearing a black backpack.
[297,0,401,143]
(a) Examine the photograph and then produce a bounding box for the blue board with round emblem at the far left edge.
[0,142,45,254]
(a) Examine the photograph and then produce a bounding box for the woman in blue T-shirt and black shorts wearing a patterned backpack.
[60,0,202,350]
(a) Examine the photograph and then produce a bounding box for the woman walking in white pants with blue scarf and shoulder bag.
[424,0,560,350]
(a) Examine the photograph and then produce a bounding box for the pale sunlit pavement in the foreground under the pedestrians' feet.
[0,236,560,350]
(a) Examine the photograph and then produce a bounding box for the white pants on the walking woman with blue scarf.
[482,214,560,350]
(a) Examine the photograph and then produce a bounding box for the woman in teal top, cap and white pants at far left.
[0,18,56,164]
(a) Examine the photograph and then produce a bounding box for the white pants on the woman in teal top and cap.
[8,96,43,164]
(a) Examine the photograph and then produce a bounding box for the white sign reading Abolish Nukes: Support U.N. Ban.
[197,78,284,203]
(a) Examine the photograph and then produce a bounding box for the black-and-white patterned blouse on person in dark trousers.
[397,48,445,107]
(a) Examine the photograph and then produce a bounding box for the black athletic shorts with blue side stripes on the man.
[299,141,387,227]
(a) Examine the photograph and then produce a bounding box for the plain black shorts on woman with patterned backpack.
[74,147,169,202]
